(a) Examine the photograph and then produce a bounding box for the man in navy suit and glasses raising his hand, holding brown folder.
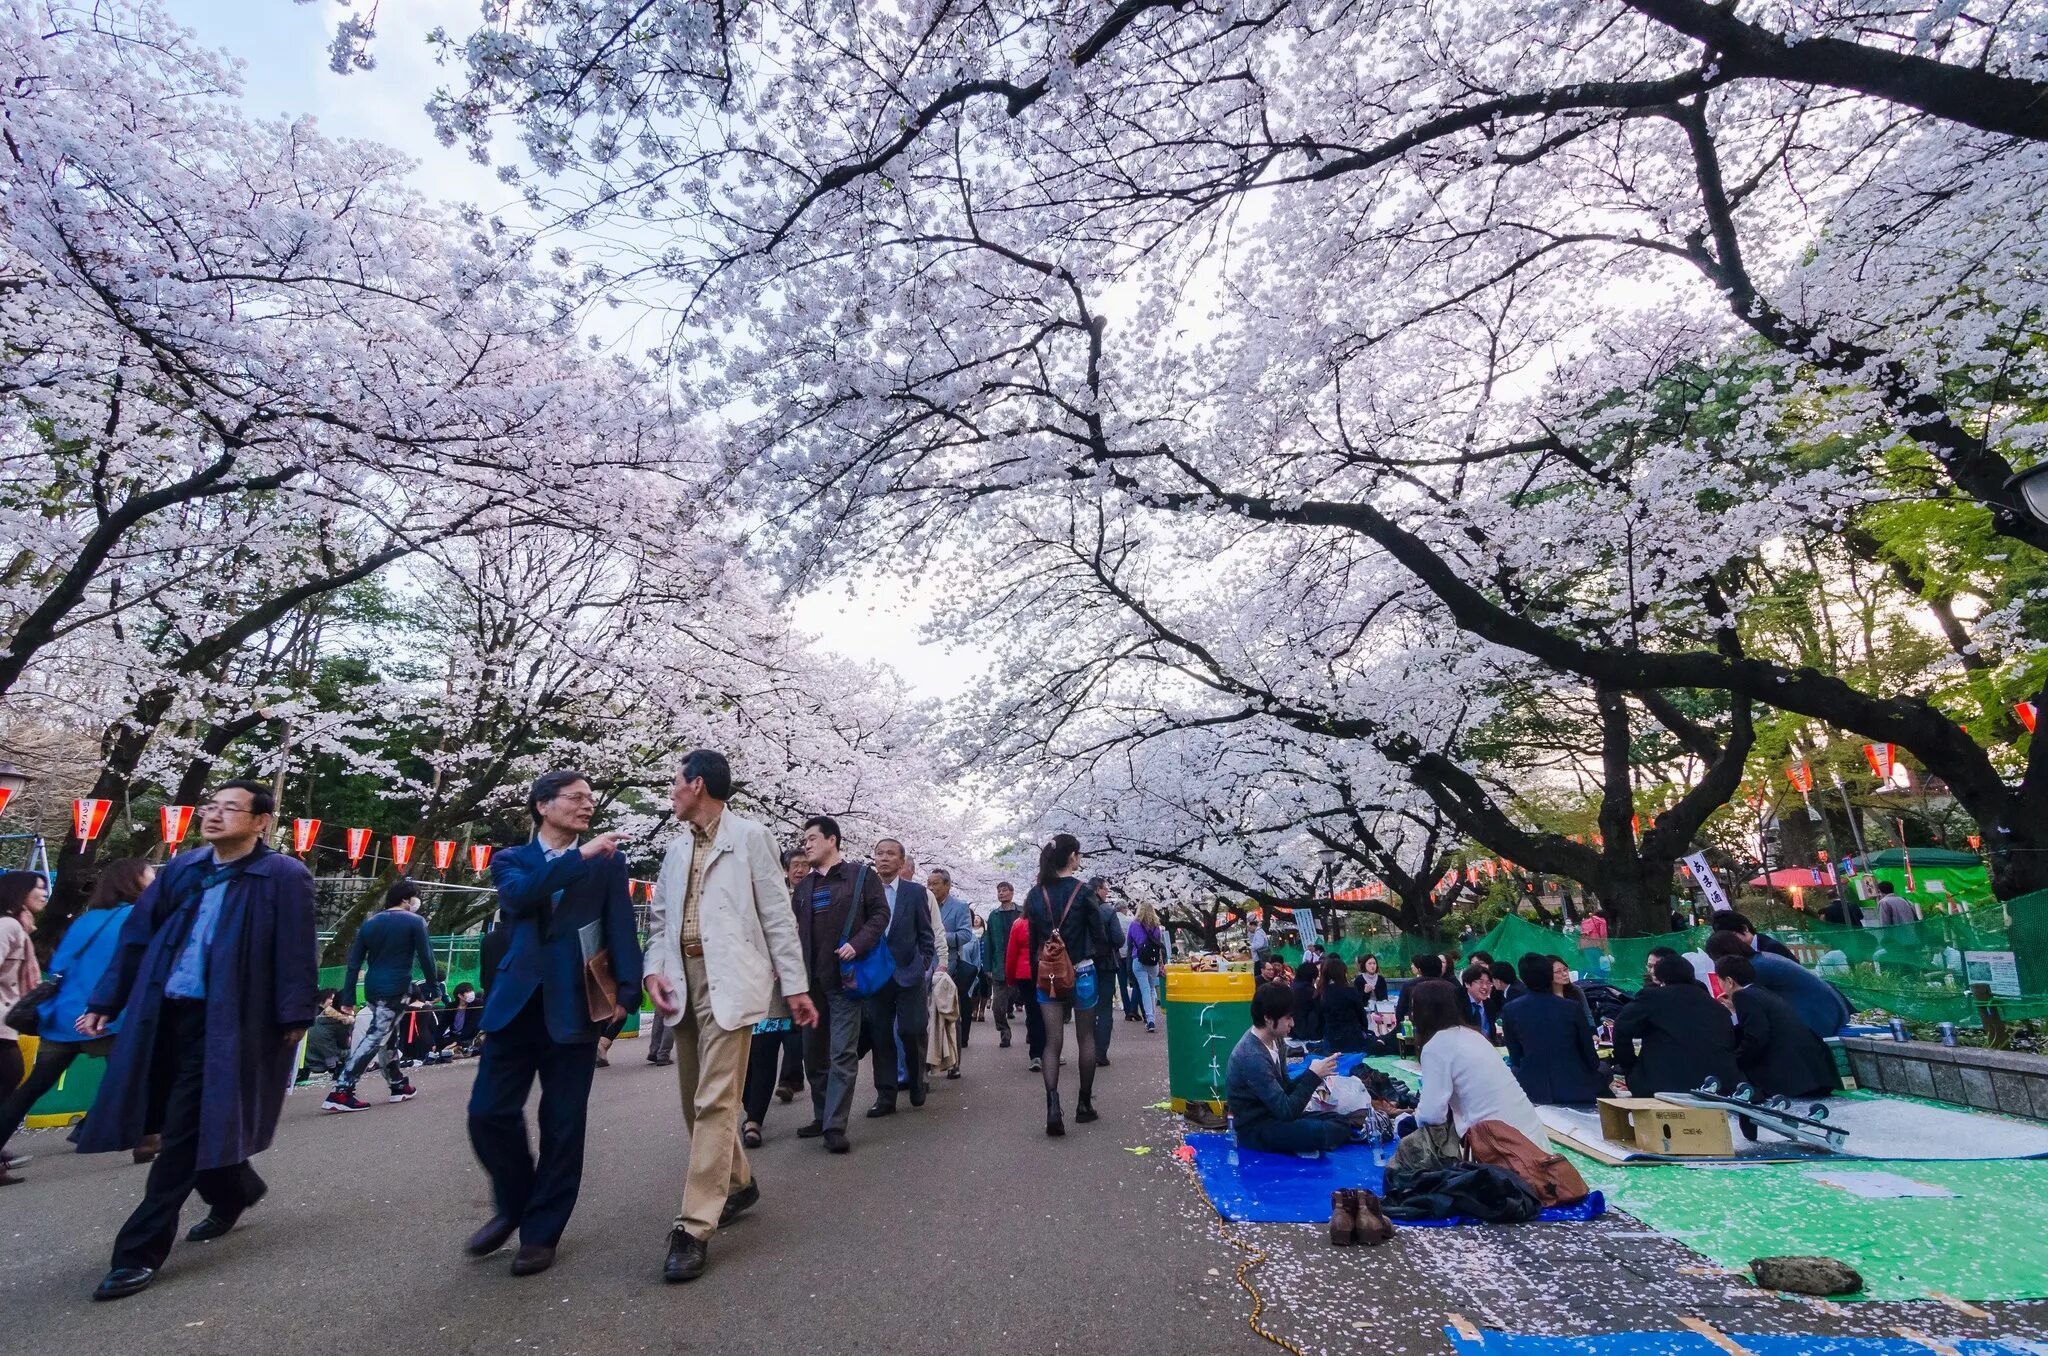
[467,770,641,1276]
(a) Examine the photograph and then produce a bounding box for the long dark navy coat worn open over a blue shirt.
[72,846,319,1168]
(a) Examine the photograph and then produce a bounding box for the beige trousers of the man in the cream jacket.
[676,957,754,1239]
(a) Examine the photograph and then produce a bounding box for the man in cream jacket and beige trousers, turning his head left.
[645,750,817,1282]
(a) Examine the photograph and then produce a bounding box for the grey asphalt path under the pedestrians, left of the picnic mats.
[0,1007,1276,1356]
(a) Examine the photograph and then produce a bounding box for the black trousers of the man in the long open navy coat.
[113,998,264,1270]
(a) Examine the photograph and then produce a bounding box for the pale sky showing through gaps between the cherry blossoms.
[166,0,977,698]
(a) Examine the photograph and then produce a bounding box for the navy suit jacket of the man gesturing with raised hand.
[481,838,641,1045]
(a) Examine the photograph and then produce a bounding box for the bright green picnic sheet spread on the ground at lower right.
[1571,1153,2048,1301]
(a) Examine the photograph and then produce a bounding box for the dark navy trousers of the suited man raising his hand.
[469,991,598,1247]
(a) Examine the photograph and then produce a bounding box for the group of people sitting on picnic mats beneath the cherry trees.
[1227,912,1851,1153]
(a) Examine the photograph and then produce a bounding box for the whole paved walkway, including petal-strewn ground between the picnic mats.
[0,1022,2048,1356]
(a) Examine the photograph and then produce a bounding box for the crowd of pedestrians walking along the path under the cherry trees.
[0,750,1169,1301]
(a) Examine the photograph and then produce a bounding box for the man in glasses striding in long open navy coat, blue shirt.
[72,780,319,1299]
